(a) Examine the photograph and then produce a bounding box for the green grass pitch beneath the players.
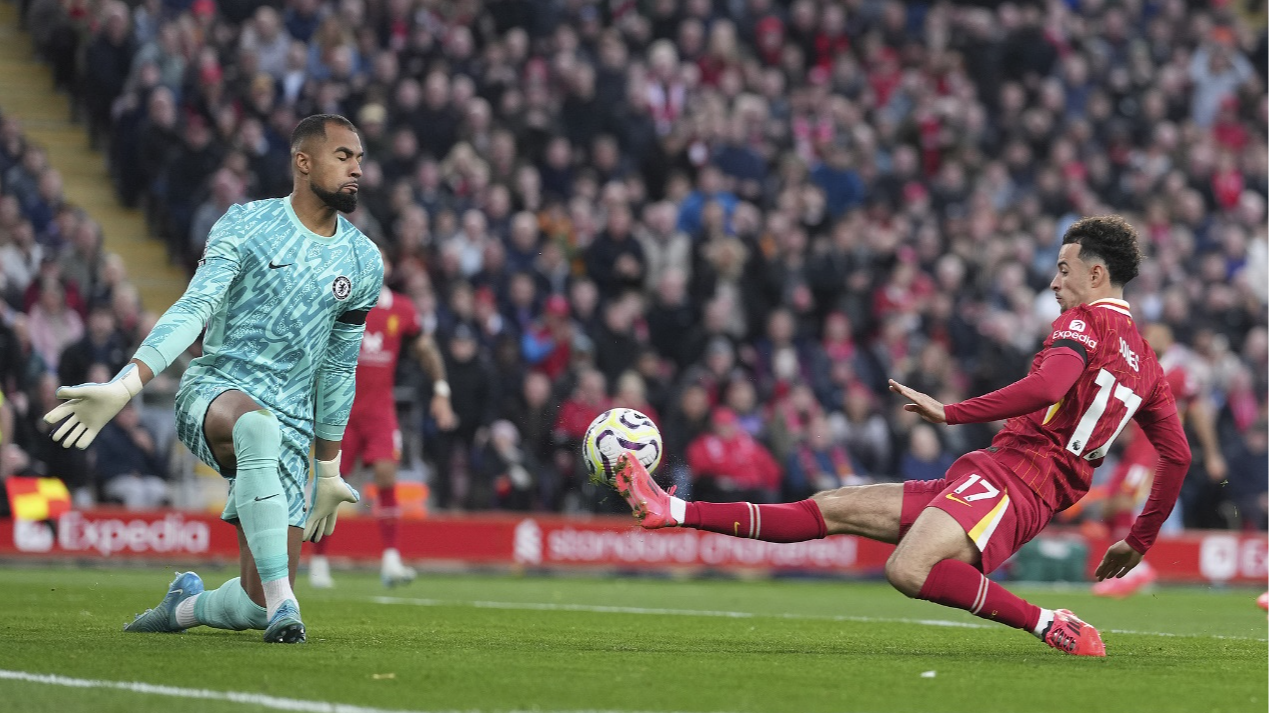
[0,567,1269,713]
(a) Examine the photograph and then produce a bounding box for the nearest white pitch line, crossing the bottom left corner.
[0,669,720,713]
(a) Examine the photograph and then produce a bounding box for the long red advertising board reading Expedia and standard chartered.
[0,510,1269,582]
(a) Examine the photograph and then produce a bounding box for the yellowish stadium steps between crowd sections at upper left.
[0,1,188,312]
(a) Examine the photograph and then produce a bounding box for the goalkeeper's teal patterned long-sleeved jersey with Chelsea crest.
[137,197,383,440]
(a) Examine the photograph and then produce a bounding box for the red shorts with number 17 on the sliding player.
[898,450,1053,573]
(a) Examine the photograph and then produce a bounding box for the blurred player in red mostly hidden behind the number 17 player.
[1093,324,1226,598]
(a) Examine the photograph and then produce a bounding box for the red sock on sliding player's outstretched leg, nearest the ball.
[683,500,829,542]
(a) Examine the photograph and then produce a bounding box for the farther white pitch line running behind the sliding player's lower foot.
[371,596,1269,642]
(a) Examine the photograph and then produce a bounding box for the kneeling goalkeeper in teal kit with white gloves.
[44,114,383,643]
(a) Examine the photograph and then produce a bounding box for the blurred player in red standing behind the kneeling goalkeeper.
[308,252,454,589]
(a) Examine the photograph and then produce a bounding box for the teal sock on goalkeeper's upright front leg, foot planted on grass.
[233,409,296,617]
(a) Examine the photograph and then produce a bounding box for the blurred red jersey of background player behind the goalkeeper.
[353,287,423,409]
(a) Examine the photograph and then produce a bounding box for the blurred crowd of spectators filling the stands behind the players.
[0,0,1269,529]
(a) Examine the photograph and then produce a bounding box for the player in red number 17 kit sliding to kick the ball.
[615,217,1190,656]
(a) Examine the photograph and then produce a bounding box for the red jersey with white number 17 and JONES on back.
[992,299,1176,510]
